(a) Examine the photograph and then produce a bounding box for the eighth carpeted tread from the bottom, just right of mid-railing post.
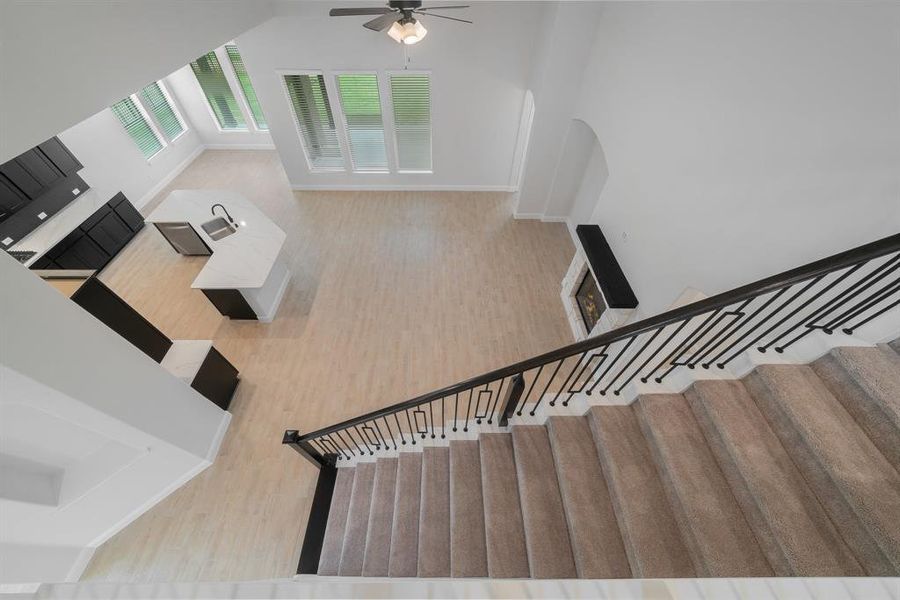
[512,425,578,579]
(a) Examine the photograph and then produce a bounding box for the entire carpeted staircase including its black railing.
[283,235,900,579]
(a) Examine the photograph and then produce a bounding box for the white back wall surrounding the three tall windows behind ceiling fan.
[236,2,541,189]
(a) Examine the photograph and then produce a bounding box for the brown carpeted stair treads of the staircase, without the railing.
[318,342,900,579]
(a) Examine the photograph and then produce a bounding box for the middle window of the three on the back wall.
[337,74,388,171]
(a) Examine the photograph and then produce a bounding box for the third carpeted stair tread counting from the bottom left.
[362,458,397,577]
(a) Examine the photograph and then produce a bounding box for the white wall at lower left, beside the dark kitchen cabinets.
[0,255,230,583]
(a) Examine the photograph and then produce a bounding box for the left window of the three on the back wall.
[284,74,344,171]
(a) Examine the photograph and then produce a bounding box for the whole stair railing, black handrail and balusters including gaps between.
[283,234,900,468]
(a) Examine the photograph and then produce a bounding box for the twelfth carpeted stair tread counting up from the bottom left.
[685,380,865,577]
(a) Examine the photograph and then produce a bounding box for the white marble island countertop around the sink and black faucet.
[146,190,287,289]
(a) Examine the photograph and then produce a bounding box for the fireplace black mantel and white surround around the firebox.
[560,225,638,340]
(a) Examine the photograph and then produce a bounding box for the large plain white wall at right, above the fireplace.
[528,2,900,315]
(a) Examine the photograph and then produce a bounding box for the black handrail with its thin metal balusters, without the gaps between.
[284,233,900,461]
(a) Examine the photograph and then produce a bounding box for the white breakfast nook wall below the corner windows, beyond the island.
[59,83,203,208]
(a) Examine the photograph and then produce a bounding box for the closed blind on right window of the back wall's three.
[391,73,431,171]
